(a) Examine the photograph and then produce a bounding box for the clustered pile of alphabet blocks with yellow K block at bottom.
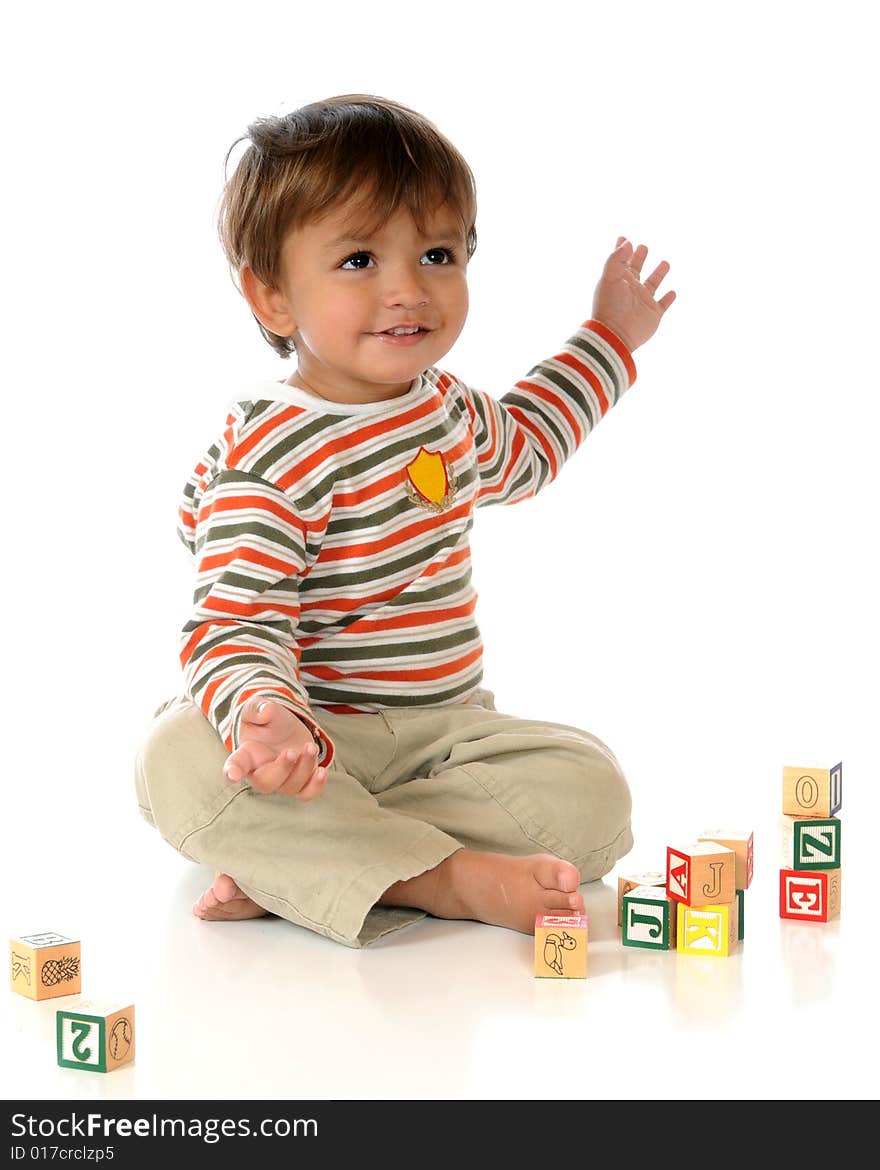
[618,828,755,958]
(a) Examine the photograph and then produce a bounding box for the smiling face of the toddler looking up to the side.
[249,198,468,402]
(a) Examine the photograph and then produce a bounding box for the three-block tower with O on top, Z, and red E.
[779,764,844,922]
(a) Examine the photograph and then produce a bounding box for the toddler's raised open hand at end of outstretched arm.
[592,235,675,352]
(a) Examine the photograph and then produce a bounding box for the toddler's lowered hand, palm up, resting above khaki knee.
[224,698,326,800]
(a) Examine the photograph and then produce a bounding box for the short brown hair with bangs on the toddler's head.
[218,94,476,358]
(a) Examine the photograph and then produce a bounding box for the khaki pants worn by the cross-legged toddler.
[136,690,632,947]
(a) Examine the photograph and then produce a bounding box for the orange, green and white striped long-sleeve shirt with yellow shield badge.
[178,321,635,763]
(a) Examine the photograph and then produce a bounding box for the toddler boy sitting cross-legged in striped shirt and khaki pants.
[136,94,675,947]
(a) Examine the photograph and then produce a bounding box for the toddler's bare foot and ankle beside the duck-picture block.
[379,849,584,935]
